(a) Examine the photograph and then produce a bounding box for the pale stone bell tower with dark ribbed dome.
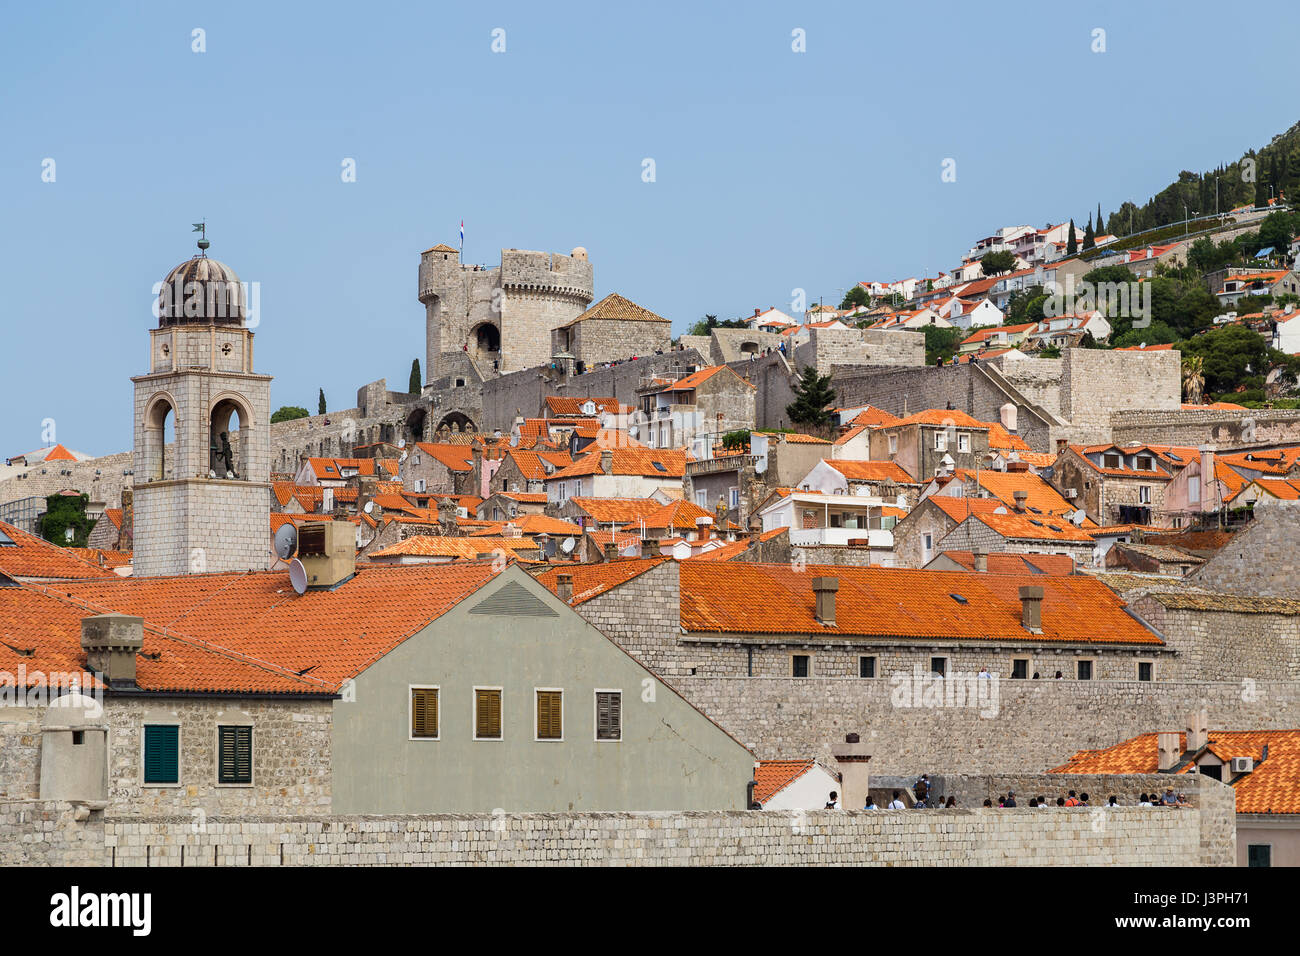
[131,238,270,578]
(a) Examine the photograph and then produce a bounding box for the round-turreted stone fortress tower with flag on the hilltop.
[420,243,593,382]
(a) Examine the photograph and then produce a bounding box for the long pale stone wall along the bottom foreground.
[0,778,1236,866]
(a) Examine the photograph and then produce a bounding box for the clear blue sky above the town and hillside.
[0,0,1300,455]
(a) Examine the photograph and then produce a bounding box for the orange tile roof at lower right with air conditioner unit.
[1048,730,1300,813]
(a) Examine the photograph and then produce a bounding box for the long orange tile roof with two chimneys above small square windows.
[680,561,1164,646]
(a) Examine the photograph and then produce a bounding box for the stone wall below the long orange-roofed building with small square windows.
[672,669,1300,775]
